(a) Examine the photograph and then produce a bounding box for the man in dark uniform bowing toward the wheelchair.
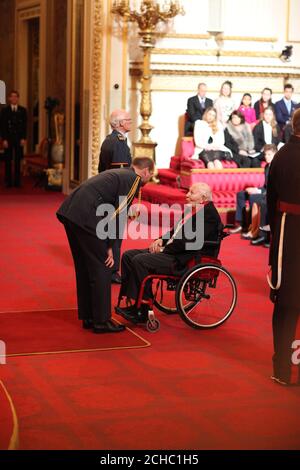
[56,157,154,333]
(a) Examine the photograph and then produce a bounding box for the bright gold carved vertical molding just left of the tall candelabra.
[91,0,103,175]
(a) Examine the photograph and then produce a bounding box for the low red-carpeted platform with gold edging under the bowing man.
[0,310,149,357]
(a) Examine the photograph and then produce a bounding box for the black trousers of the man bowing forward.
[64,221,112,323]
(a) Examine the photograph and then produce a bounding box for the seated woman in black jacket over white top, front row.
[253,108,280,161]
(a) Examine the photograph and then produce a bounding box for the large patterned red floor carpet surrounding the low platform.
[0,185,300,449]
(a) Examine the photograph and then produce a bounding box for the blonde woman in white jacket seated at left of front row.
[193,108,232,169]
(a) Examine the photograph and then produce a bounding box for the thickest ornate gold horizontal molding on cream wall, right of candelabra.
[152,48,279,59]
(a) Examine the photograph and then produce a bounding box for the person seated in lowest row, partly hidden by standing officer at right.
[231,144,277,238]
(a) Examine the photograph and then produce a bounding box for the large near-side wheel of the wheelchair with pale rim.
[176,264,237,329]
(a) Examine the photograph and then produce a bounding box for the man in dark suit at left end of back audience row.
[184,83,213,135]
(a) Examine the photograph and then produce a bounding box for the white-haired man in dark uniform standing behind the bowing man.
[98,109,131,284]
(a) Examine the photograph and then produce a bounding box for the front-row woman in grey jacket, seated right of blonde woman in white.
[224,111,260,168]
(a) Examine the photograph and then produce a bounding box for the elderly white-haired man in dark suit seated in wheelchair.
[115,183,221,323]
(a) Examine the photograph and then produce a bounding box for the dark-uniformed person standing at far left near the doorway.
[0,90,27,187]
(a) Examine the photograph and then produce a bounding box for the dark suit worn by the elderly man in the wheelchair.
[121,202,221,299]
